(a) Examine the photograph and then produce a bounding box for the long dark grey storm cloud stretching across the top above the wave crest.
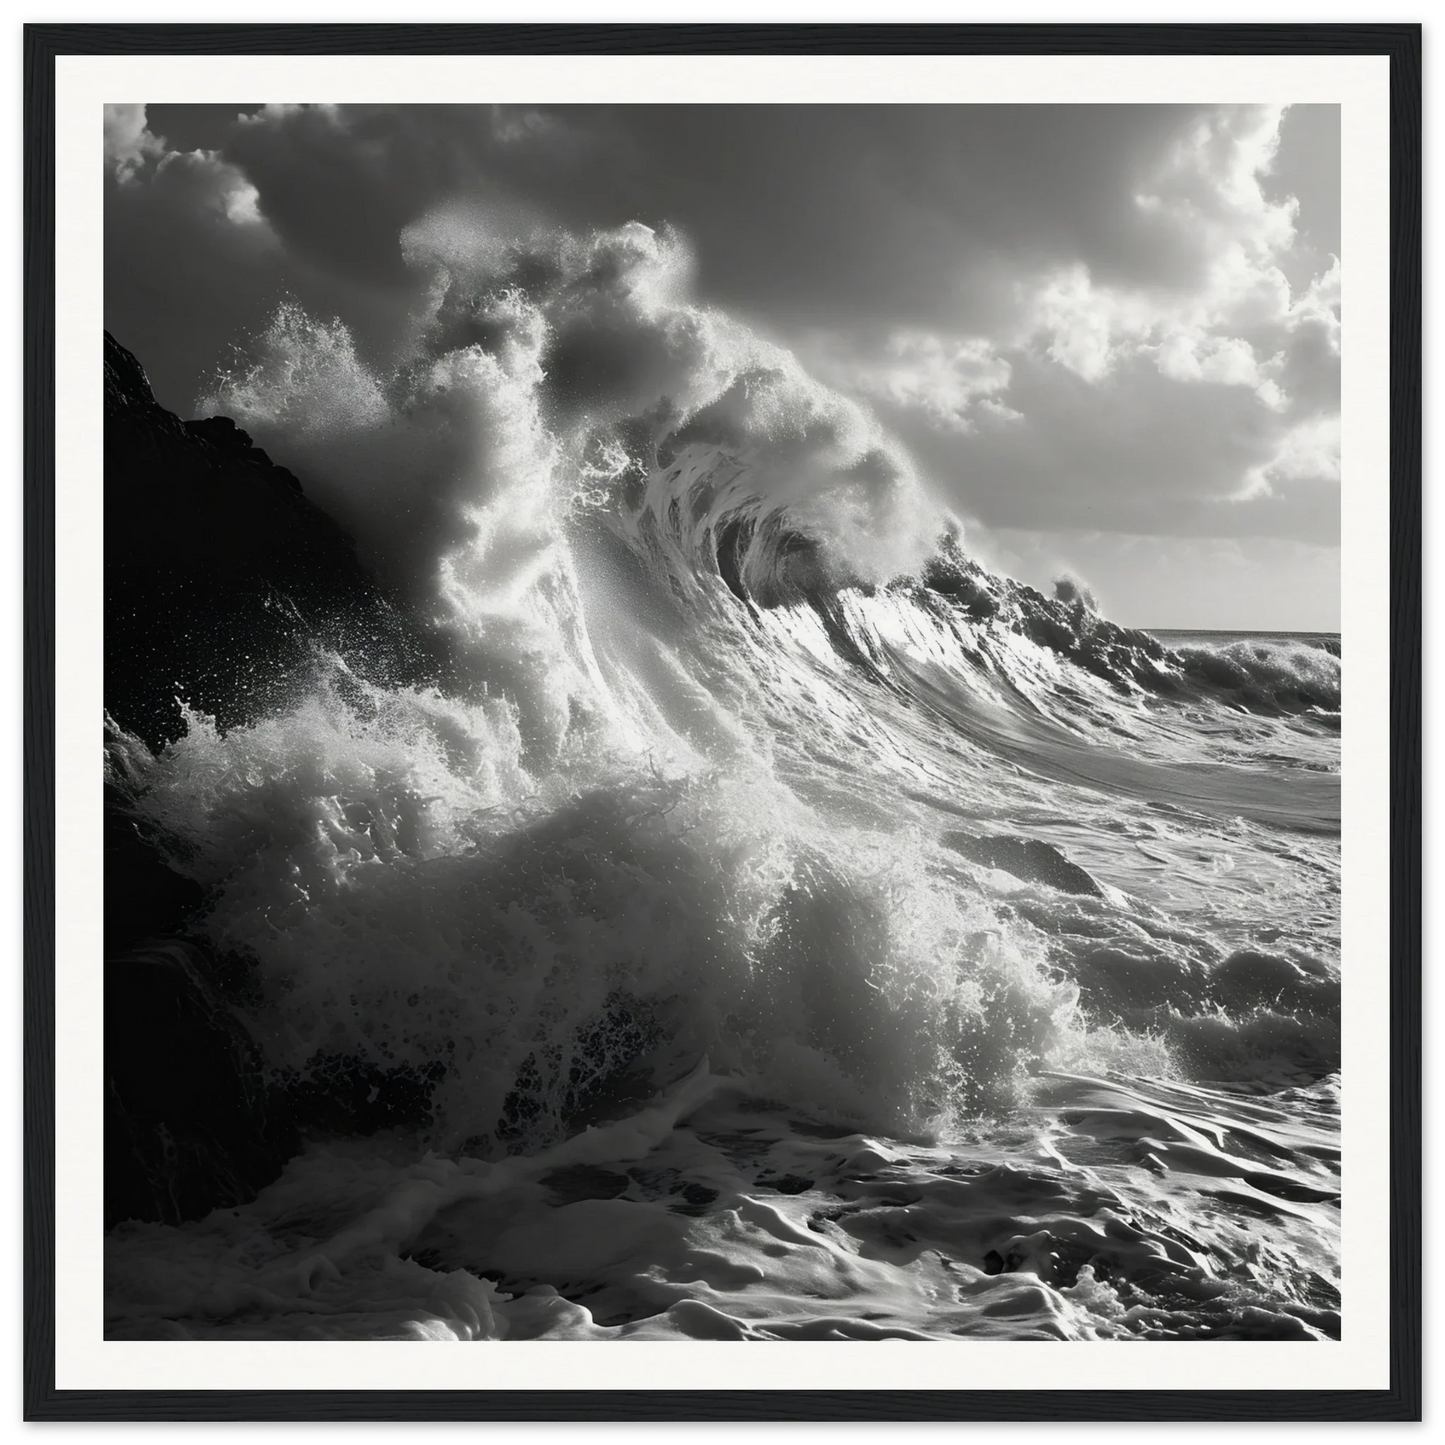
[124,105,1236,335]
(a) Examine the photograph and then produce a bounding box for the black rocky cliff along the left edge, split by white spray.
[104,334,447,1228]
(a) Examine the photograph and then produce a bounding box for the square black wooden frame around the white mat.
[12,17,1433,1439]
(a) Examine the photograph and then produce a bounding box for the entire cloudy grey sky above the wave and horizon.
[105,96,1340,630]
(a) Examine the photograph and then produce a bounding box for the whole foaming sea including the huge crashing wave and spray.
[107,227,1341,1341]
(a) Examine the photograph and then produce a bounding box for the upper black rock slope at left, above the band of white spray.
[105,334,444,747]
